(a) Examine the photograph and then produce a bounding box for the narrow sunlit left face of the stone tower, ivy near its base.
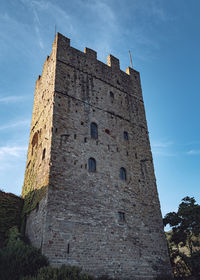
[22,36,57,247]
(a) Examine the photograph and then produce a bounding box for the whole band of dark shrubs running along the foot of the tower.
[0,227,172,280]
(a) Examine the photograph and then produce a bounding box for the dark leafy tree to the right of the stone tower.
[163,197,200,279]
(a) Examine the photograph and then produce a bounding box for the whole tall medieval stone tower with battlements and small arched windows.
[23,34,170,279]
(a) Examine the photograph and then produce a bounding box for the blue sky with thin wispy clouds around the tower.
[0,0,200,218]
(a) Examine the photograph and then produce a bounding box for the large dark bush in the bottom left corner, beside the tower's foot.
[0,227,48,280]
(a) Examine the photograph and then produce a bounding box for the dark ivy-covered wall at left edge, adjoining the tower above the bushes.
[0,190,23,247]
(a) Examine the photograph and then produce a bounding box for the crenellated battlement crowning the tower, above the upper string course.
[37,33,142,97]
